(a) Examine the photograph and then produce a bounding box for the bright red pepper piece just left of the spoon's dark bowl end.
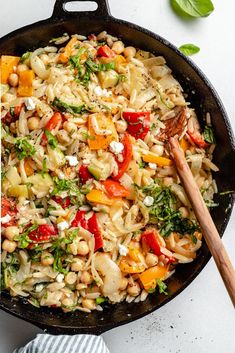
[122,112,150,140]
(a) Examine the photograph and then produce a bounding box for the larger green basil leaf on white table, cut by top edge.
[171,0,214,17]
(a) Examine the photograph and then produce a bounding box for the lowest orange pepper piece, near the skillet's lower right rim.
[139,265,168,291]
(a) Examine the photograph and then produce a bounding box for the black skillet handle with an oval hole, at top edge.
[51,0,110,20]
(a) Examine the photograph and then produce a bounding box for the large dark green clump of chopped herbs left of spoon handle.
[142,183,198,237]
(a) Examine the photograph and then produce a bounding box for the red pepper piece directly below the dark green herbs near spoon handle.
[141,229,175,263]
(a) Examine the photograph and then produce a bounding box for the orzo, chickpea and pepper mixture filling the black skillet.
[1,32,218,312]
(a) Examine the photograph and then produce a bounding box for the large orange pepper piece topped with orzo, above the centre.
[88,113,118,150]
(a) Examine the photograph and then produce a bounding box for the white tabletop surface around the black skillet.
[0,0,235,353]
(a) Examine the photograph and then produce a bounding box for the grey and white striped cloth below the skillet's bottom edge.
[13,334,110,353]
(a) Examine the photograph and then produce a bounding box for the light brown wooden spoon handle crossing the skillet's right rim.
[169,137,235,307]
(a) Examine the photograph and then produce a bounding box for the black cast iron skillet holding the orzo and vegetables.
[0,0,235,334]
